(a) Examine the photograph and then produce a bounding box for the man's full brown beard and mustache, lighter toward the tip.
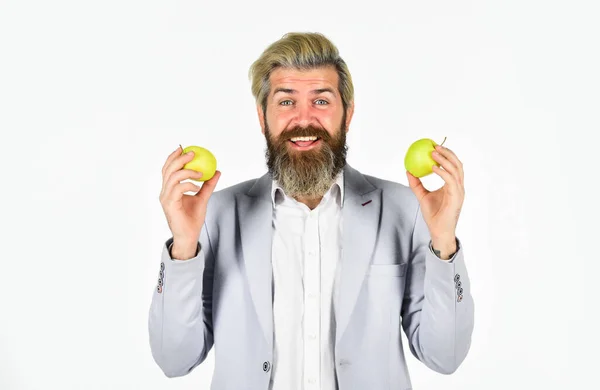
[265,115,348,199]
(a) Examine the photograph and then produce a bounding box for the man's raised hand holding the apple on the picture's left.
[159,147,221,260]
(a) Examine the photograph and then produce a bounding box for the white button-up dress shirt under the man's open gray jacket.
[270,172,344,390]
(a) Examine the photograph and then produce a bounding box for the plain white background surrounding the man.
[0,0,600,390]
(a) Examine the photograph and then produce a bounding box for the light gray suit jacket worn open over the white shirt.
[148,165,474,390]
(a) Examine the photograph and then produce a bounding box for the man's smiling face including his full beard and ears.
[258,67,353,198]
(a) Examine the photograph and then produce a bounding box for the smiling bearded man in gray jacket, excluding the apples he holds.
[148,33,474,390]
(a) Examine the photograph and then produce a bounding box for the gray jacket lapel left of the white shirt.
[236,174,273,347]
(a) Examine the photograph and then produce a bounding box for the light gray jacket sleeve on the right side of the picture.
[402,208,474,374]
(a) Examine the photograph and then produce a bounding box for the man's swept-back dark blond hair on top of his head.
[248,32,354,112]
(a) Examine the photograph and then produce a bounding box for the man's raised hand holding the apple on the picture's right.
[406,145,465,248]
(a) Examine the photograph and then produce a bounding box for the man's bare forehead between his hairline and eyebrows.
[269,66,339,93]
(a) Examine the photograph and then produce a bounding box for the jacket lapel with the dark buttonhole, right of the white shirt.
[336,165,381,344]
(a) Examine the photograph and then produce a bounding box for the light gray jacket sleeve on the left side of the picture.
[148,225,214,377]
